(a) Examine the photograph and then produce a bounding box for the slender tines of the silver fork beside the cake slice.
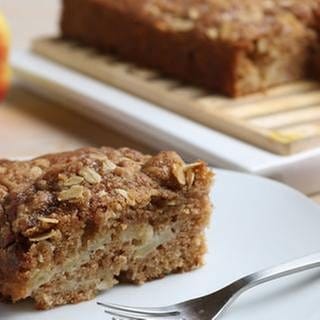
[97,302,180,319]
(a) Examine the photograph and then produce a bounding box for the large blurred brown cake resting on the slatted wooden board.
[61,0,320,96]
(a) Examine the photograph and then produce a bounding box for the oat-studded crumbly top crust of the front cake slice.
[0,147,211,250]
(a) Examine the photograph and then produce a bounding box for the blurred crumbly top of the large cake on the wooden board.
[112,0,320,42]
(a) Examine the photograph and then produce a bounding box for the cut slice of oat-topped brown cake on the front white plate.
[0,147,212,309]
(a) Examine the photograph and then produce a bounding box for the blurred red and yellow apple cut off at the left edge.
[0,12,10,101]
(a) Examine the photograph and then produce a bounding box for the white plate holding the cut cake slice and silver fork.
[0,170,320,320]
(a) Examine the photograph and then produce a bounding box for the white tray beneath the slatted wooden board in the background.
[11,51,320,194]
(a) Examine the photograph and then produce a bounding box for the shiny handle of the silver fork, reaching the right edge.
[238,253,320,292]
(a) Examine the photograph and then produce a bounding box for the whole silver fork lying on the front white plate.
[98,253,320,320]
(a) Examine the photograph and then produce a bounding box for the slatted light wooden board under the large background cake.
[32,38,320,155]
